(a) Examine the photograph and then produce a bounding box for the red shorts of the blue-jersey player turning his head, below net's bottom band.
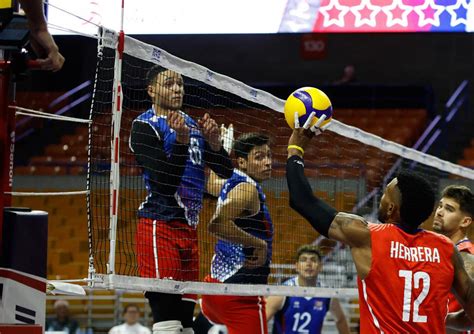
[201,279,268,334]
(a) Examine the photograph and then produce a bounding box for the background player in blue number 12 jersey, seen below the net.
[266,245,350,334]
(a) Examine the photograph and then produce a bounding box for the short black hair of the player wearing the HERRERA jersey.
[397,170,435,230]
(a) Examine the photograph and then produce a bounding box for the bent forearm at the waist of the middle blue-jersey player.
[208,215,259,247]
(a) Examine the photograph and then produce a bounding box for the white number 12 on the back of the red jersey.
[398,270,430,322]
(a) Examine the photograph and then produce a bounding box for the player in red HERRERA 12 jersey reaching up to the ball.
[286,116,474,333]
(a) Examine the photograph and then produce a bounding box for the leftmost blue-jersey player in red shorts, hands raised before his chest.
[130,66,233,334]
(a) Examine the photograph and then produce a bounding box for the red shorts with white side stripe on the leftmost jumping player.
[135,218,199,300]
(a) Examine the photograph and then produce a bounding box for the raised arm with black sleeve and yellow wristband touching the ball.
[286,115,370,247]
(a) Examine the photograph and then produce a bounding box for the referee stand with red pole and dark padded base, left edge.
[0,5,48,334]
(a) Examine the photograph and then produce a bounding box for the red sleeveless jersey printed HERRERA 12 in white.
[358,224,454,333]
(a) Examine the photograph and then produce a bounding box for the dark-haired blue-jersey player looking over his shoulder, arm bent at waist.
[202,133,273,334]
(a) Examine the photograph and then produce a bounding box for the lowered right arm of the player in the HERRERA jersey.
[452,246,474,321]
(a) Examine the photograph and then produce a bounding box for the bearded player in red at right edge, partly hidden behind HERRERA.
[433,185,474,332]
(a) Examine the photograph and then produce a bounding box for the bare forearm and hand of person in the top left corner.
[20,0,64,72]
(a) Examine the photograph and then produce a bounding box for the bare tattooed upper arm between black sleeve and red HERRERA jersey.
[328,212,370,247]
